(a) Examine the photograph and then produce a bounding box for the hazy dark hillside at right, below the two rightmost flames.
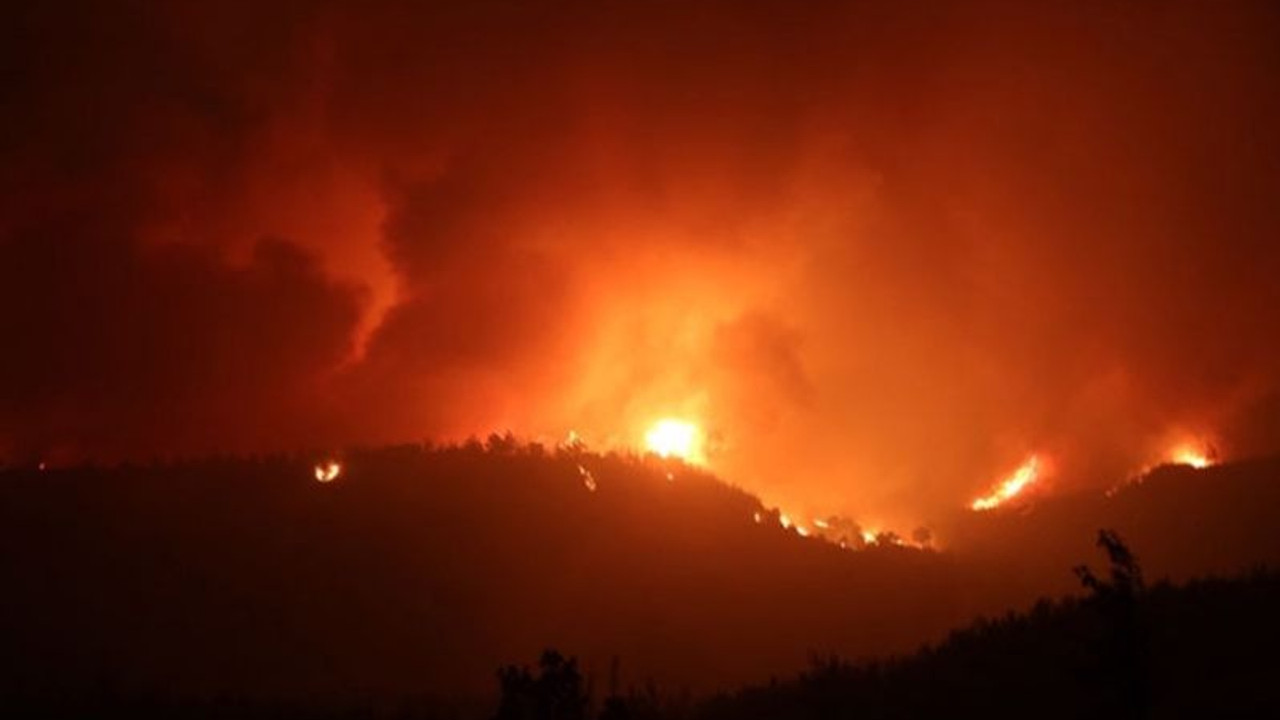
[940,457,1280,612]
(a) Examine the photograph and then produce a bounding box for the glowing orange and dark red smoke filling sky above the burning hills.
[0,0,1280,521]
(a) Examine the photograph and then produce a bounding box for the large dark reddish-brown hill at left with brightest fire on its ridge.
[0,443,963,698]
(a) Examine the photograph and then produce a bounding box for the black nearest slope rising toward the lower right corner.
[701,561,1280,720]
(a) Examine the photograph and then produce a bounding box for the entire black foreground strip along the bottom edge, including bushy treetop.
[5,550,1280,720]
